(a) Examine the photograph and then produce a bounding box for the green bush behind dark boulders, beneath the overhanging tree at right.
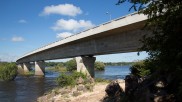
[130,61,151,77]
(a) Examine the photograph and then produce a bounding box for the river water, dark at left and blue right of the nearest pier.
[0,66,130,102]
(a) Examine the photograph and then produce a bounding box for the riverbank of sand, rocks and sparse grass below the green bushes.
[37,80,125,102]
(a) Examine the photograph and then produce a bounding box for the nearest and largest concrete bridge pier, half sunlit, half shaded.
[76,56,96,78]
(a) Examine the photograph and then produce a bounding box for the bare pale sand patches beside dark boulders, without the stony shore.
[55,81,125,102]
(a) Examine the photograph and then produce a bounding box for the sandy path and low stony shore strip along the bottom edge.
[38,80,125,102]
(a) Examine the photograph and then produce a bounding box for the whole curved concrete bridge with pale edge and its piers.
[16,13,151,77]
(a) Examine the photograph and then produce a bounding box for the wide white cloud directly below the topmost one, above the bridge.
[52,19,95,32]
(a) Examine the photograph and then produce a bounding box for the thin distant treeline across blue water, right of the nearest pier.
[104,62,134,66]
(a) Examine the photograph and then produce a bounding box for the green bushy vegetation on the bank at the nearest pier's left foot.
[56,72,86,87]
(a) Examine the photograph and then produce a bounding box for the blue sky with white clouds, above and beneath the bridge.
[0,0,148,62]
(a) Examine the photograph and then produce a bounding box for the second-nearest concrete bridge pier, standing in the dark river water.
[35,61,45,75]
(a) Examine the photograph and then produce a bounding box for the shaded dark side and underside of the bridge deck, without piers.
[17,22,151,63]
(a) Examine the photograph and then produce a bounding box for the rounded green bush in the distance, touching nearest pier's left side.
[65,59,77,71]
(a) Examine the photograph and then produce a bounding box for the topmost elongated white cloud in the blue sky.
[41,4,82,16]
